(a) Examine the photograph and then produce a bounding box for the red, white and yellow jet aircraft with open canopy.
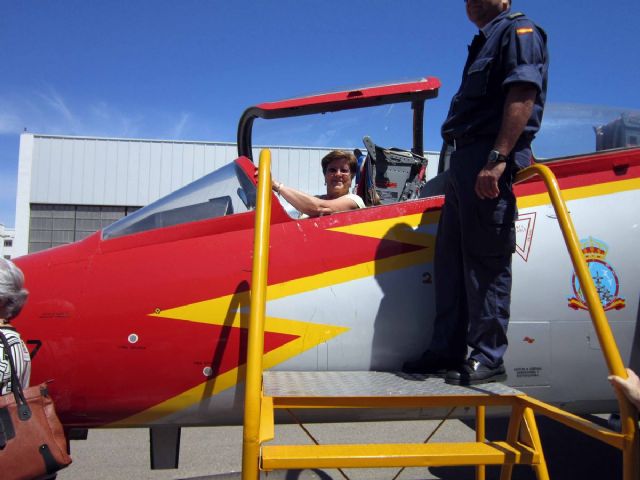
[15,78,640,464]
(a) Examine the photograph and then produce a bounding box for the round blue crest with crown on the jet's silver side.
[568,237,626,311]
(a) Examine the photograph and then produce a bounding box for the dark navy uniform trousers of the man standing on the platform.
[429,138,531,368]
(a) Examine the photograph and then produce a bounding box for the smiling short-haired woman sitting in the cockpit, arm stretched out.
[271,150,364,218]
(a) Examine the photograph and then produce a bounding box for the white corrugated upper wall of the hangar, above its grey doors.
[25,134,340,206]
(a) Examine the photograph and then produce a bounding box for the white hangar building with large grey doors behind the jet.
[12,133,437,257]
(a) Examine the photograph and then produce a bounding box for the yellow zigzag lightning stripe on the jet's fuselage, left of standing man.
[109,213,437,427]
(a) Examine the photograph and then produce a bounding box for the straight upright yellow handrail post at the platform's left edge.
[242,149,271,480]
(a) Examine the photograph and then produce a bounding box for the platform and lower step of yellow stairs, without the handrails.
[260,372,547,478]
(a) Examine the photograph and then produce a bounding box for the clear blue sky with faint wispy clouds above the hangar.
[0,0,640,226]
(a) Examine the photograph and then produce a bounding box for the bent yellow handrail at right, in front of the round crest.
[516,164,638,480]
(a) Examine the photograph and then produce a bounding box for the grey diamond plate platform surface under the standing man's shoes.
[262,371,524,398]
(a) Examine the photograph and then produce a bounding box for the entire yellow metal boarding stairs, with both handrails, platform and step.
[242,150,640,480]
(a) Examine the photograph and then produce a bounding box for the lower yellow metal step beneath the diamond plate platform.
[261,442,540,470]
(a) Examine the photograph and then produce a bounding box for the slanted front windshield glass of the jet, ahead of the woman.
[102,162,256,239]
